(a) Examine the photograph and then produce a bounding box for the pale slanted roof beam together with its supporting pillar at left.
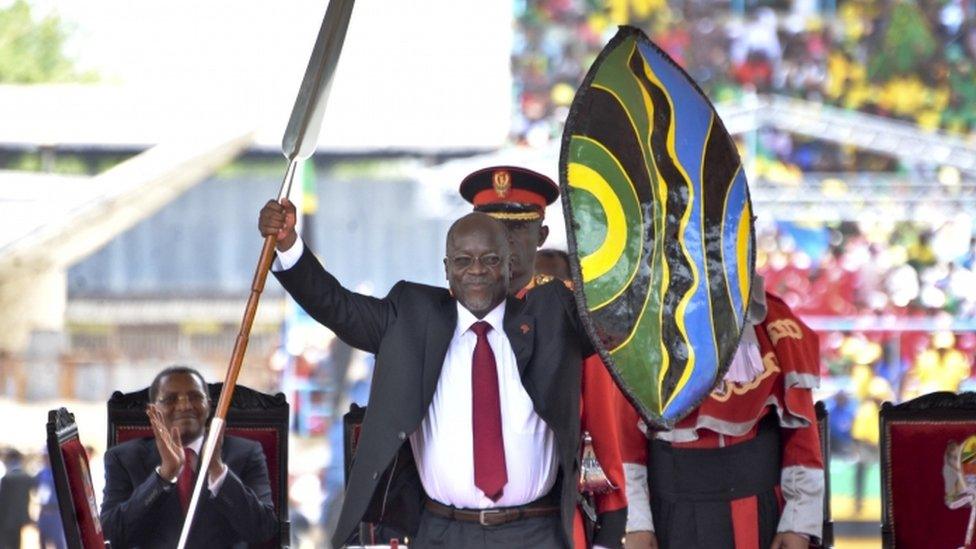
[0,130,253,351]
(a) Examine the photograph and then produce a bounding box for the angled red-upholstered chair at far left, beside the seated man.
[47,408,105,549]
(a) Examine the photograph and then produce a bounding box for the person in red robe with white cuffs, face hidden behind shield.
[619,277,824,549]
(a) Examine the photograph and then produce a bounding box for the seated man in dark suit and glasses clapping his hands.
[101,366,278,549]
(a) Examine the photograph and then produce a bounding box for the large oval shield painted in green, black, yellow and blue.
[559,27,755,429]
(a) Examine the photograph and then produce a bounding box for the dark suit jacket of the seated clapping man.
[101,436,278,549]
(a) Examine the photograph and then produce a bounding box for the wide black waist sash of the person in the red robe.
[648,412,782,501]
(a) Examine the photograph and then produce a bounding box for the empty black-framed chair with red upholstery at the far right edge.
[880,392,976,548]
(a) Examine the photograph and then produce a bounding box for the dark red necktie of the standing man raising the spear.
[471,320,508,501]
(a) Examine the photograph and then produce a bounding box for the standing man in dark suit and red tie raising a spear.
[258,200,593,548]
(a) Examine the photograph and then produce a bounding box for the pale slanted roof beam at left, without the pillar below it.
[0,131,252,280]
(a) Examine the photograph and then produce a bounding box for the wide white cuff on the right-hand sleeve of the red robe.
[776,465,824,540]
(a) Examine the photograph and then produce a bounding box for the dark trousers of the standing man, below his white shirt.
[410,509,566,549]
